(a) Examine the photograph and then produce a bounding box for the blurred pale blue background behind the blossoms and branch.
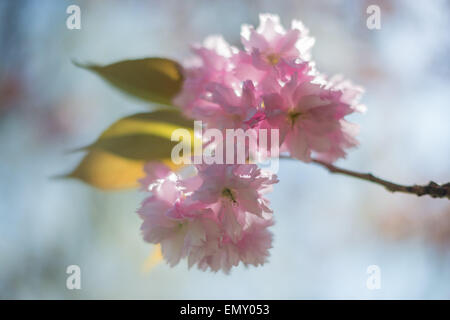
[0,0,450,299]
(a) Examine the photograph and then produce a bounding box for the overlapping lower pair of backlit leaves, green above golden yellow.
[65,110,193,190]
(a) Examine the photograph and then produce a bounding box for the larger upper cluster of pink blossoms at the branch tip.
[174,14,364,162]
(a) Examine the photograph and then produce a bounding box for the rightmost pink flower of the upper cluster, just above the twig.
[263,74,357,162]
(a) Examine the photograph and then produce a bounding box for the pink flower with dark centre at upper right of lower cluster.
[192,164,278,241]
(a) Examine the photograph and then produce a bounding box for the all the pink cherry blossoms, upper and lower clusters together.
[138,14,364,272]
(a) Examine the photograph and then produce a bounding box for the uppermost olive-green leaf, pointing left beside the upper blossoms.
[75,58,183,106]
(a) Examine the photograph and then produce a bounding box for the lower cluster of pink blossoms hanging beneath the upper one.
[138,163,277,272]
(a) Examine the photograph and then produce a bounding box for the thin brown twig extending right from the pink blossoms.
[282,157,450,199]
